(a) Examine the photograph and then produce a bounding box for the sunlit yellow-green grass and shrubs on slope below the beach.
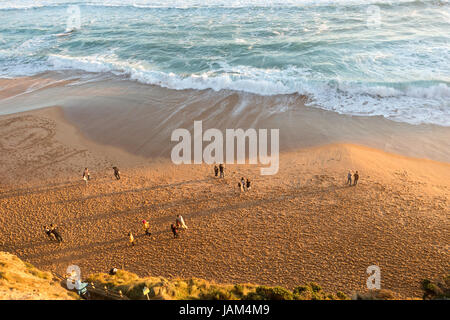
[0,252,442,300]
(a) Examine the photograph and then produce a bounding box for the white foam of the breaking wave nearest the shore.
[49,55,450,126]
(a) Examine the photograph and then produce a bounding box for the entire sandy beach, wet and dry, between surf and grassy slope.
[0,74,450,297]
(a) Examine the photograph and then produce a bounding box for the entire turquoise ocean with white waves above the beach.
[0,0,450,126]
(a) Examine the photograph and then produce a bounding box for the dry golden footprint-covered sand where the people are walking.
[0,108,450,297]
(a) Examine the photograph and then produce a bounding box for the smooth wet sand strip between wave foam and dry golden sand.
[0,72,450,162]
